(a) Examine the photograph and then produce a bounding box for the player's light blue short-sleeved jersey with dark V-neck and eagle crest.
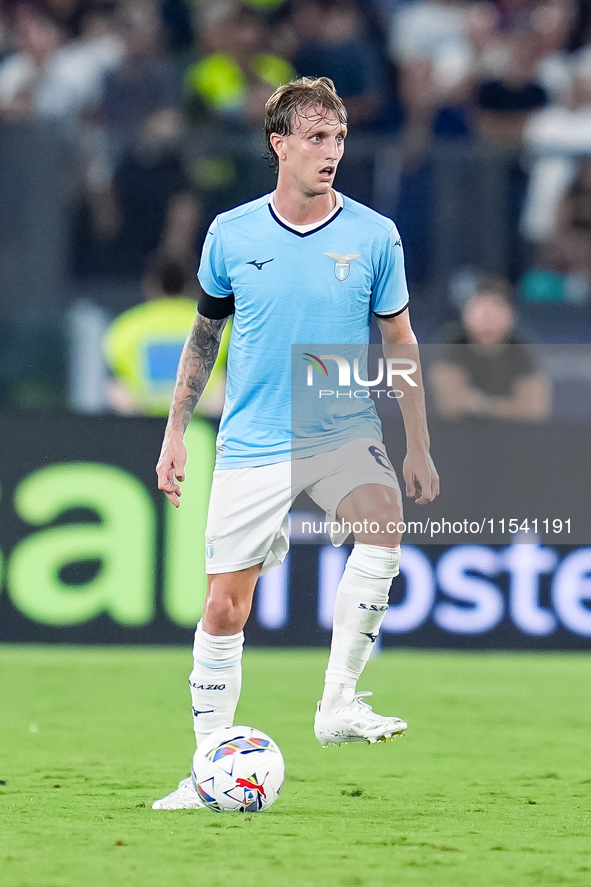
[198,195,408,468]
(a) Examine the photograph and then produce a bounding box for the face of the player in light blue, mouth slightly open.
[278,108,347,197]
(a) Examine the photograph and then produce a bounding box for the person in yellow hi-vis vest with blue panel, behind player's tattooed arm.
[104,257,230,416]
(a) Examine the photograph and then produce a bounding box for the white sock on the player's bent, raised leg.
[321,542,400,714]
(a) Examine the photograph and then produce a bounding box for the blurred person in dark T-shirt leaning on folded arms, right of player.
[431,278,551,421]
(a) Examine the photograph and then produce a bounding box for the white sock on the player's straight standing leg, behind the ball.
[189,622,244,745]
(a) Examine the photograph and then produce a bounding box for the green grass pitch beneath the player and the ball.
[0,646,591,887]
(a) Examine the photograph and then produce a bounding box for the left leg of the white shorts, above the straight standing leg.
[205,462,291,574]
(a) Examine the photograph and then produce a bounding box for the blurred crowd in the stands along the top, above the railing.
[0,0,591,135]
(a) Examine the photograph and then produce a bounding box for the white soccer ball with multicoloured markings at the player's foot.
[191,727,285,813]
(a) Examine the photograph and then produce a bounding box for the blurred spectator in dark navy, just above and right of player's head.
[293,0,386,128]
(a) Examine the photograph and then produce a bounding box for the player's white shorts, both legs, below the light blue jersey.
[205,437,400,573]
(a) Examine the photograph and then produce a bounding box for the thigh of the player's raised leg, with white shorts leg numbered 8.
[307,438,403,545]
